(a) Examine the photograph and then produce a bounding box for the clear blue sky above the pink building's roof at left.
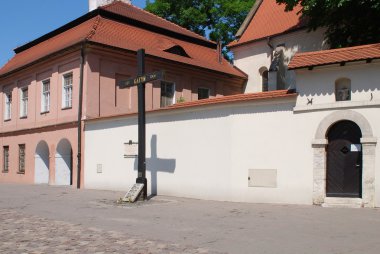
[0,0,145,66]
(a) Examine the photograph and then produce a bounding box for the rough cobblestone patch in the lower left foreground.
[0,209,220,254]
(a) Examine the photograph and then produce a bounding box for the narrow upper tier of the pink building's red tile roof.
[100,1,210,42]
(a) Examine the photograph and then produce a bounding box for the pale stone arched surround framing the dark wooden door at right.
[312,110,377,207]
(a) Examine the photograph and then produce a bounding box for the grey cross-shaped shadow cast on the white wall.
[133,135,176,195]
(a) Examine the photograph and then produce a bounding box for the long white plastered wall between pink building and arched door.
[85,100,380,206]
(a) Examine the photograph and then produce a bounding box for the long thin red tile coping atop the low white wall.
[86,90,298,121]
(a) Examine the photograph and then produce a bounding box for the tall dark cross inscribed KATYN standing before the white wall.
[119,49,164,200]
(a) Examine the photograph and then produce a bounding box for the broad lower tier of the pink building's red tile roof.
[0,2,246,79]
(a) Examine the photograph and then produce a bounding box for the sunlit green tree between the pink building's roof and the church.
[145,0,255,53]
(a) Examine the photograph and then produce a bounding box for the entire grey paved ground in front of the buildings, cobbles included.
[0,183,380,254]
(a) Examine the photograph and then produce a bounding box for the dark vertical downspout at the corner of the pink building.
[77,42,86,189]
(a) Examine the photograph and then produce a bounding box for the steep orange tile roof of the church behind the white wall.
[228,0,304,47]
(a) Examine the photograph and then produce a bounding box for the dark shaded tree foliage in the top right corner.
[276,0,380,48]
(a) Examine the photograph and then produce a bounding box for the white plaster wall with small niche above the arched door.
[294,60,380,207]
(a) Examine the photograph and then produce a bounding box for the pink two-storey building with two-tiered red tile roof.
[0,1,247,187]
